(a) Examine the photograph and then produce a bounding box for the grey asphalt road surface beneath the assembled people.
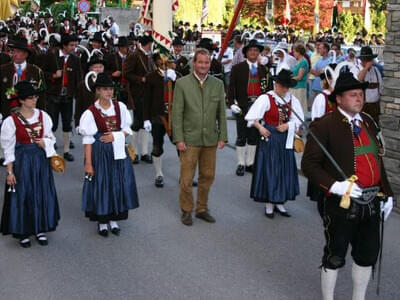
[0,115,400,300]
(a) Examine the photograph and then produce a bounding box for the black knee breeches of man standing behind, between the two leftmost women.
[47,95,73,132]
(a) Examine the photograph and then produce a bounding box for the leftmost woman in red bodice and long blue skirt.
[0,81,60,248]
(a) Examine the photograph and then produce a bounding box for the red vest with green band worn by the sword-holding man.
[353,123,381,187]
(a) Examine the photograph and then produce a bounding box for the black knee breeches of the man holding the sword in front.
[318,197,380,269]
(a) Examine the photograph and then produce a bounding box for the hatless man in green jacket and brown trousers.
[172,48,228,225]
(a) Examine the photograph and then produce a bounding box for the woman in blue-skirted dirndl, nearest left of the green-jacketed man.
[79,73,139,237]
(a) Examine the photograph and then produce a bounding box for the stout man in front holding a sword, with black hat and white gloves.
[302,72,393,300]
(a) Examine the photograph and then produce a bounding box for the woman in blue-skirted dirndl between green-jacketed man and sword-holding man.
[245,69,304,219]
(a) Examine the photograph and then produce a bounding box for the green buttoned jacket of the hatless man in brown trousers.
[172,73,228,146]
